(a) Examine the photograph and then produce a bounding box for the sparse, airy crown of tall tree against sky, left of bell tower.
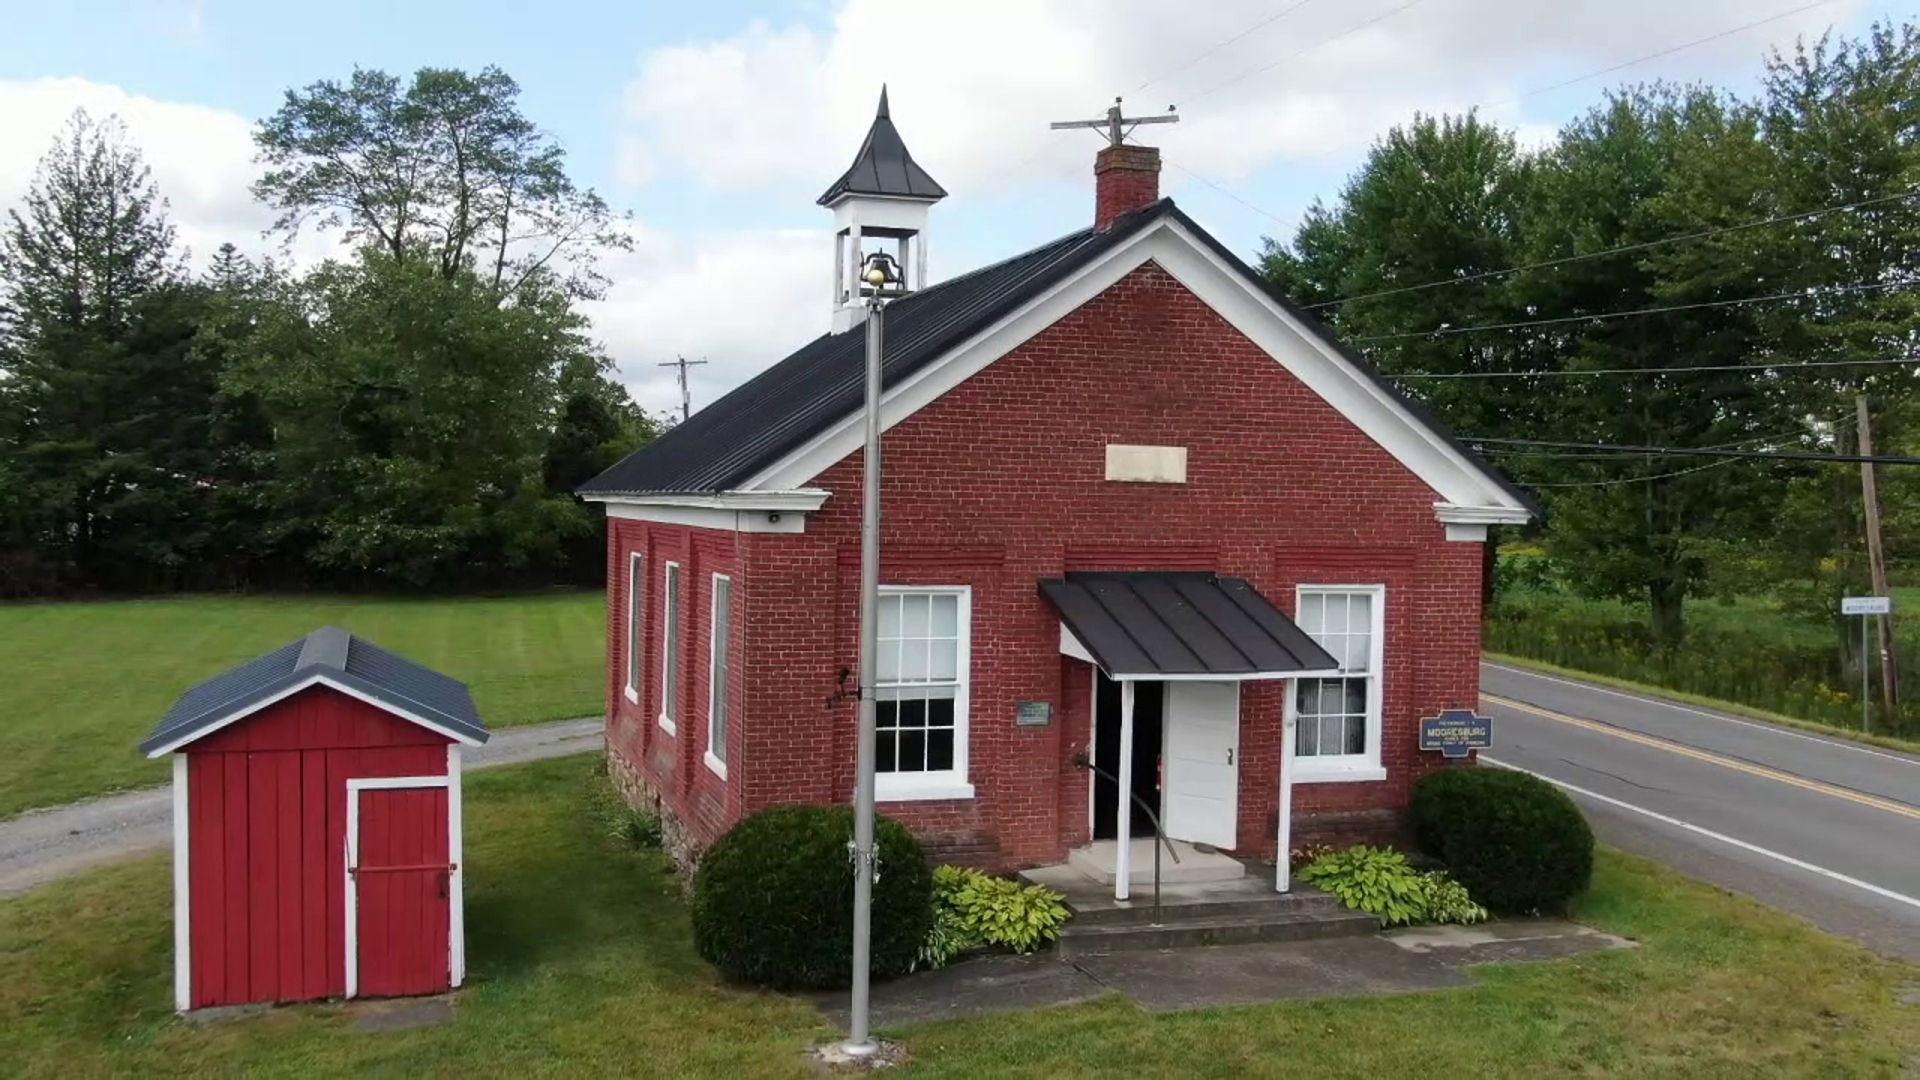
[253,67,630,298]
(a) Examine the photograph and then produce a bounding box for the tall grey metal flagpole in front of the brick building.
[841,252,906,1059]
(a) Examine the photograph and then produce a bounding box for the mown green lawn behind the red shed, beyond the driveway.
[0,592,607,817]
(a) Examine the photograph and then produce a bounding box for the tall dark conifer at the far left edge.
[0,111,213,590]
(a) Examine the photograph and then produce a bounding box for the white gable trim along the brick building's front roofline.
[741,217,1532,521]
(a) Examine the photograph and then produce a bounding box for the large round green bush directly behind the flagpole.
[693,807,933,990]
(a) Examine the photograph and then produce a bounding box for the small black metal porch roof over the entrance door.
[1041,573,1340,678]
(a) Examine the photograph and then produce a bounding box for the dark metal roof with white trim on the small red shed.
[140,626,488,753]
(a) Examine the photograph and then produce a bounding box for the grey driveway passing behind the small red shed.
[0,717,605,897]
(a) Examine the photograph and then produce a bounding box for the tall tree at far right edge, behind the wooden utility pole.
[1749,23,1920,686]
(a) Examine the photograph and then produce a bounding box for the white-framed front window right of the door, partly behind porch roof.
[1288,584,1386,780]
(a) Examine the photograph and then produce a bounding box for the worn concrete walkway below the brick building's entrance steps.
[814,919,1632,1028]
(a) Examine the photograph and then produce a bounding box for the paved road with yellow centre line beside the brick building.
[1480,663,1920,963]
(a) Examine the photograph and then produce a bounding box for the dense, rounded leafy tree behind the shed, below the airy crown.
[225,246,599,586]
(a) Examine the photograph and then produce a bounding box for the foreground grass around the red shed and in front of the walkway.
[0,757,1920,1080]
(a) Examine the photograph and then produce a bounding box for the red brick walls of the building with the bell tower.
[668,265,1480,865]
